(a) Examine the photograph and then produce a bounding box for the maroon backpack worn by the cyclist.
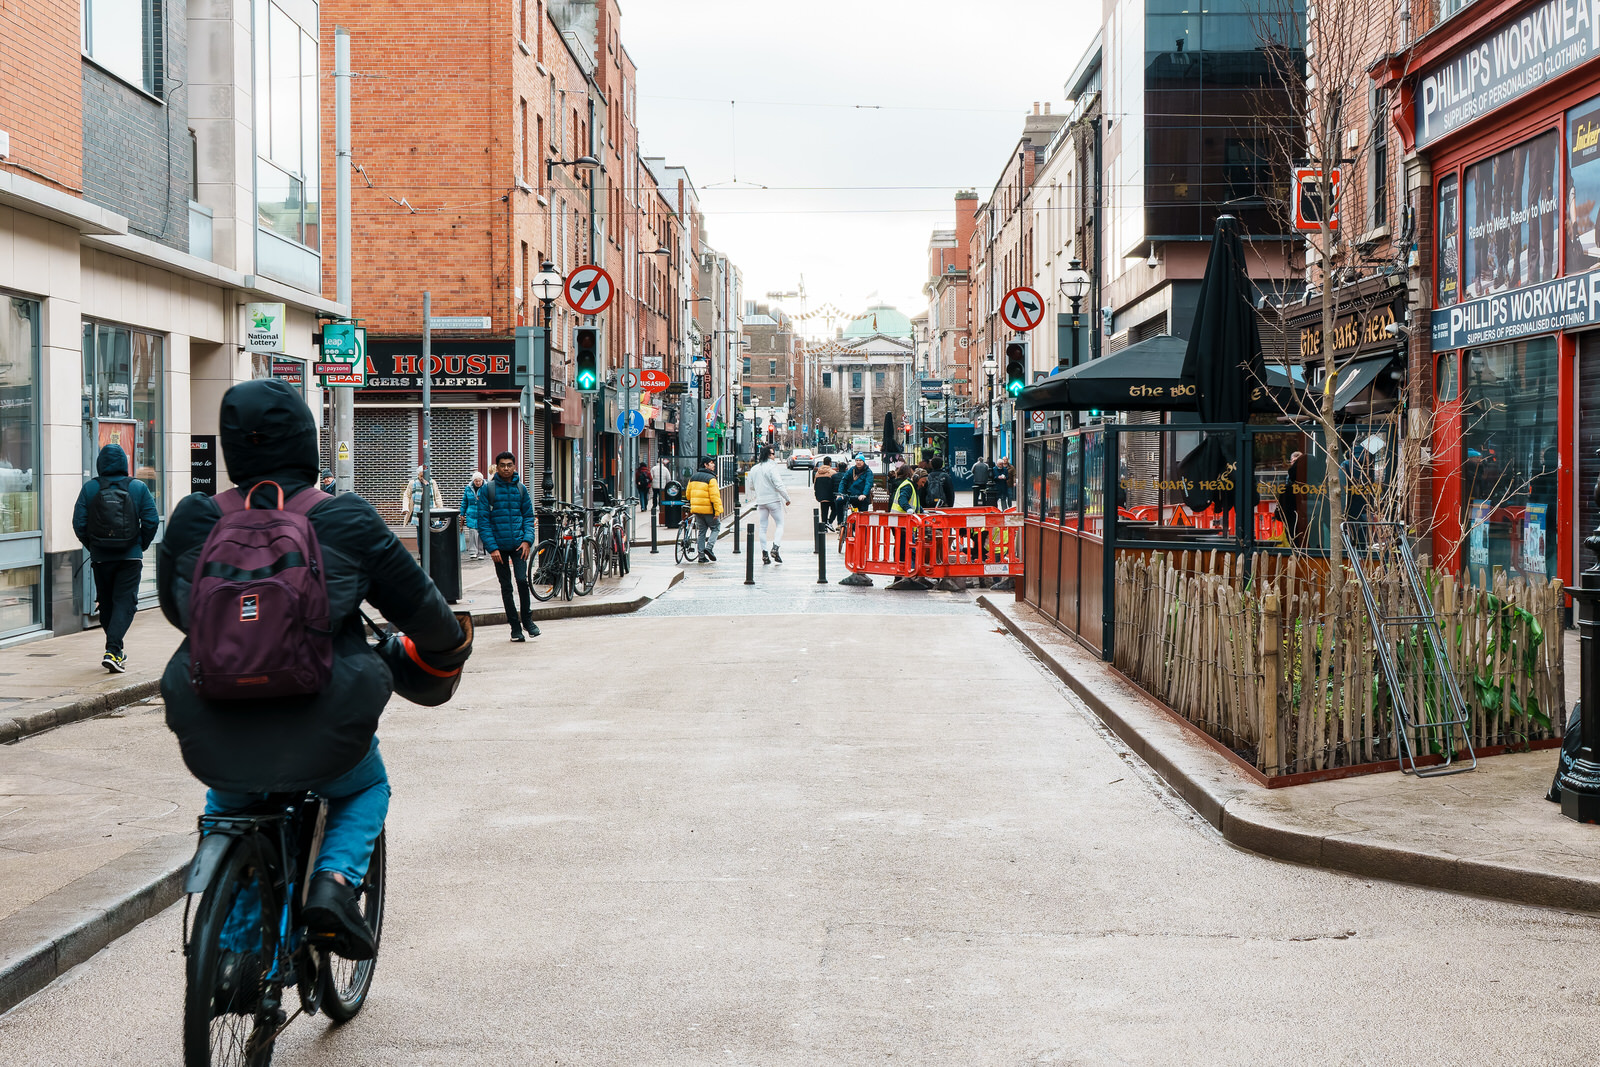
[189,482,333,701]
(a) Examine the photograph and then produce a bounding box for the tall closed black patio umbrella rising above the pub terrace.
[1179,214,1267,507]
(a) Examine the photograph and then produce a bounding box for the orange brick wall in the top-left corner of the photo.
[0,0,83,192]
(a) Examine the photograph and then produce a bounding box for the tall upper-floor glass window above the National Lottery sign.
[256,2,322,250]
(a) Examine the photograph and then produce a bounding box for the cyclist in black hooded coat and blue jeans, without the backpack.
[155,379,472,960]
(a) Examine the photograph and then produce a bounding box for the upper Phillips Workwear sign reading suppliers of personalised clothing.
[1416,0,1600,149]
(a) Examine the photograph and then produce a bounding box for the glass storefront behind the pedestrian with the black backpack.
[80,320,166,611]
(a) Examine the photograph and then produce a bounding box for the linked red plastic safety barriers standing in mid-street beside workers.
[845,507,1022,579]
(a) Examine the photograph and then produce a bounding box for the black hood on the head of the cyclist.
[219,378,318,485]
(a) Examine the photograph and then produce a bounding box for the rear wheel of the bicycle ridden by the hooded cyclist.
[184,845,282,1067]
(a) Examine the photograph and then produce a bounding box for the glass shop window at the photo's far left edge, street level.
[0,296,43,637]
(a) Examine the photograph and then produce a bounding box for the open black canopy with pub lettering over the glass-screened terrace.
[1016,336,1299,411]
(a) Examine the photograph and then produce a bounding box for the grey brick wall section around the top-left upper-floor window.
[75,0,190,251]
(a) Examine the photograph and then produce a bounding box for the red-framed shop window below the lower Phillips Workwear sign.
[1461,338,1560,577]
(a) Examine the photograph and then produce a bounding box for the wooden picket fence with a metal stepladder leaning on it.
[1115,552,1566,776]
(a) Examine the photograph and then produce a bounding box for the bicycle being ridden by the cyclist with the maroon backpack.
[182,792,387,1067]
